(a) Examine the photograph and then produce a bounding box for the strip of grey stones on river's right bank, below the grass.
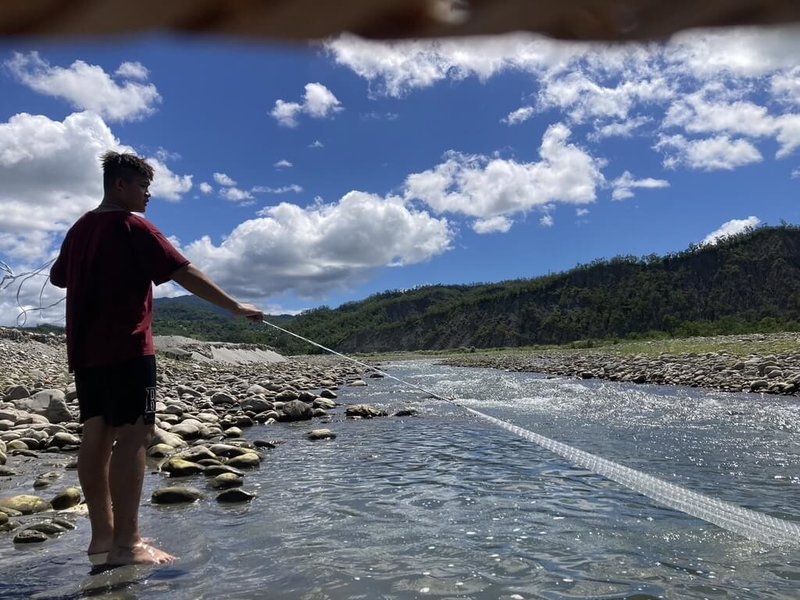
[440,333,800,395]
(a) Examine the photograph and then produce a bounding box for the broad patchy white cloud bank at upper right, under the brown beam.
[326,26,800,177]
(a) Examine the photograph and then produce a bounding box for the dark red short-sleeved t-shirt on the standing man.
[50,211,189,371]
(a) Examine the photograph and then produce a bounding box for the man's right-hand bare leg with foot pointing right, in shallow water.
[107,418,175,565]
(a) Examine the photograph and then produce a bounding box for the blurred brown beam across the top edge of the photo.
[0,0,800,41]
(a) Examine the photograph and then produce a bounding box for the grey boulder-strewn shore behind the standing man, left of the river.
[0,328,400,544]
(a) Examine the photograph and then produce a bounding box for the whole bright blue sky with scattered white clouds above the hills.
[0,28,800,325]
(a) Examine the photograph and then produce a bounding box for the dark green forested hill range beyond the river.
[155,226,800,353]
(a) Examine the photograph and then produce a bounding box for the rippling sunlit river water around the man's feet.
[0,362,800,600]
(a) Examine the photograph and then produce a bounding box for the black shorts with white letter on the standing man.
[75,356,156,427]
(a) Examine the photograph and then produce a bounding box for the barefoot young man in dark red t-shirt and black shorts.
[50,152,264,565]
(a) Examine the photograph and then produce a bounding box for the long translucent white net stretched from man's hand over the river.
[262,320,800,546]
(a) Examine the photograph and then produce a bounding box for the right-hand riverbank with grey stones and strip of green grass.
[437,332,800,395]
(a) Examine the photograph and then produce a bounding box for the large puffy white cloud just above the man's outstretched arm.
[184,191,453,298]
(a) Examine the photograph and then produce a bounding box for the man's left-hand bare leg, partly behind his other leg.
[78,417,114,554]
